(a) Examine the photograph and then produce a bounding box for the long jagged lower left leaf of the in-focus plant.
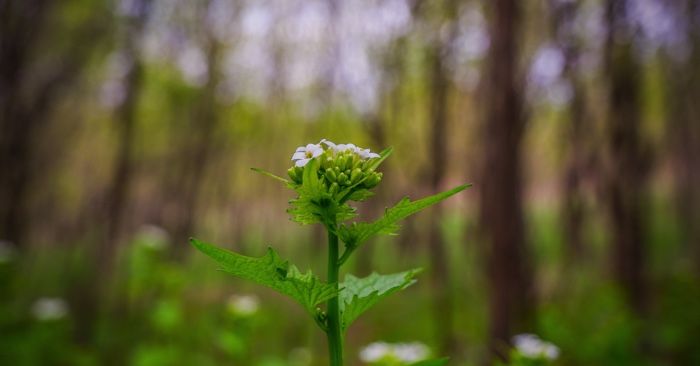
[190,238,338,316]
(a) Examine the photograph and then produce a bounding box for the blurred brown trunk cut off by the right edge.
[666,0,700,275]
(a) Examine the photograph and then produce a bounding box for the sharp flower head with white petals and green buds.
[287,139,382,195]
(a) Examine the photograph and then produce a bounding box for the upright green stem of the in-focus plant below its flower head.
[326,228,343,366]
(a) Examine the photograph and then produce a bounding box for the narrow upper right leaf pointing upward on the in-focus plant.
[338,184,471,250]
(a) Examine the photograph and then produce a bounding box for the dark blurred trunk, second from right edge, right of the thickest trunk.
[606,0,649,313]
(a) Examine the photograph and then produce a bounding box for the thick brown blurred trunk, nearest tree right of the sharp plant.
[479,0,533,357]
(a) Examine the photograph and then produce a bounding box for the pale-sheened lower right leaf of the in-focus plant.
[338,269,422,330]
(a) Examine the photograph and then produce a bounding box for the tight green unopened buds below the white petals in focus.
[287,145,382,202]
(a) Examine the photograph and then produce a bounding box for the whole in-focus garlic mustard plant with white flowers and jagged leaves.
[191,139,469,366]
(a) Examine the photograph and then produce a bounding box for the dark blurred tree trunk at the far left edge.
[0,0,52,247]
